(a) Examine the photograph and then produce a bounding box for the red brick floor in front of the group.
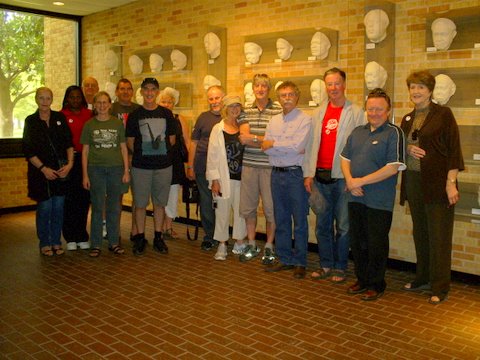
[0,212,480,360]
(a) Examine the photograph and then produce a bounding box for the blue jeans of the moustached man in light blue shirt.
[272,168,308,266]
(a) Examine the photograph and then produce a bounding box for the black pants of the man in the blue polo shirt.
[348,202,392,292]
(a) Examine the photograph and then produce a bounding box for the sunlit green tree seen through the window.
[0,10,45,137]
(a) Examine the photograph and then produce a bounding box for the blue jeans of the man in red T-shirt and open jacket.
[314,179,350,270]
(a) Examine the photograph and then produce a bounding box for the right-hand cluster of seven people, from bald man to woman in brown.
[187,68,464,304]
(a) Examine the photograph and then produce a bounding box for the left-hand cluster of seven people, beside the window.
[23,77,188,257]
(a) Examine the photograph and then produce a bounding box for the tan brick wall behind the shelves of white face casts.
[4,0,480,274]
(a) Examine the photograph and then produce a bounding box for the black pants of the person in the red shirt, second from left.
[62,153,90,243]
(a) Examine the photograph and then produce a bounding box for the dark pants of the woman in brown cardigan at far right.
[405,171,455,297]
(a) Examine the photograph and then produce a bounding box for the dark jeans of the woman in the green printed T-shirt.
[88,166,123,248]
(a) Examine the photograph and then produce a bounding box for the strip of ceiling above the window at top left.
[0,0,136,16]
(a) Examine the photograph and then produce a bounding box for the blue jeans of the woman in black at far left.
[36,196,65,248]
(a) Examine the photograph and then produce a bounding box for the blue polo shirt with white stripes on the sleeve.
[341,121,406,211]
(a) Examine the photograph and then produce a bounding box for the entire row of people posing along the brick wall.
[24,68,464,304]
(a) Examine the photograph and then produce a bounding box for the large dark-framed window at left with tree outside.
[0,8,79,157]
